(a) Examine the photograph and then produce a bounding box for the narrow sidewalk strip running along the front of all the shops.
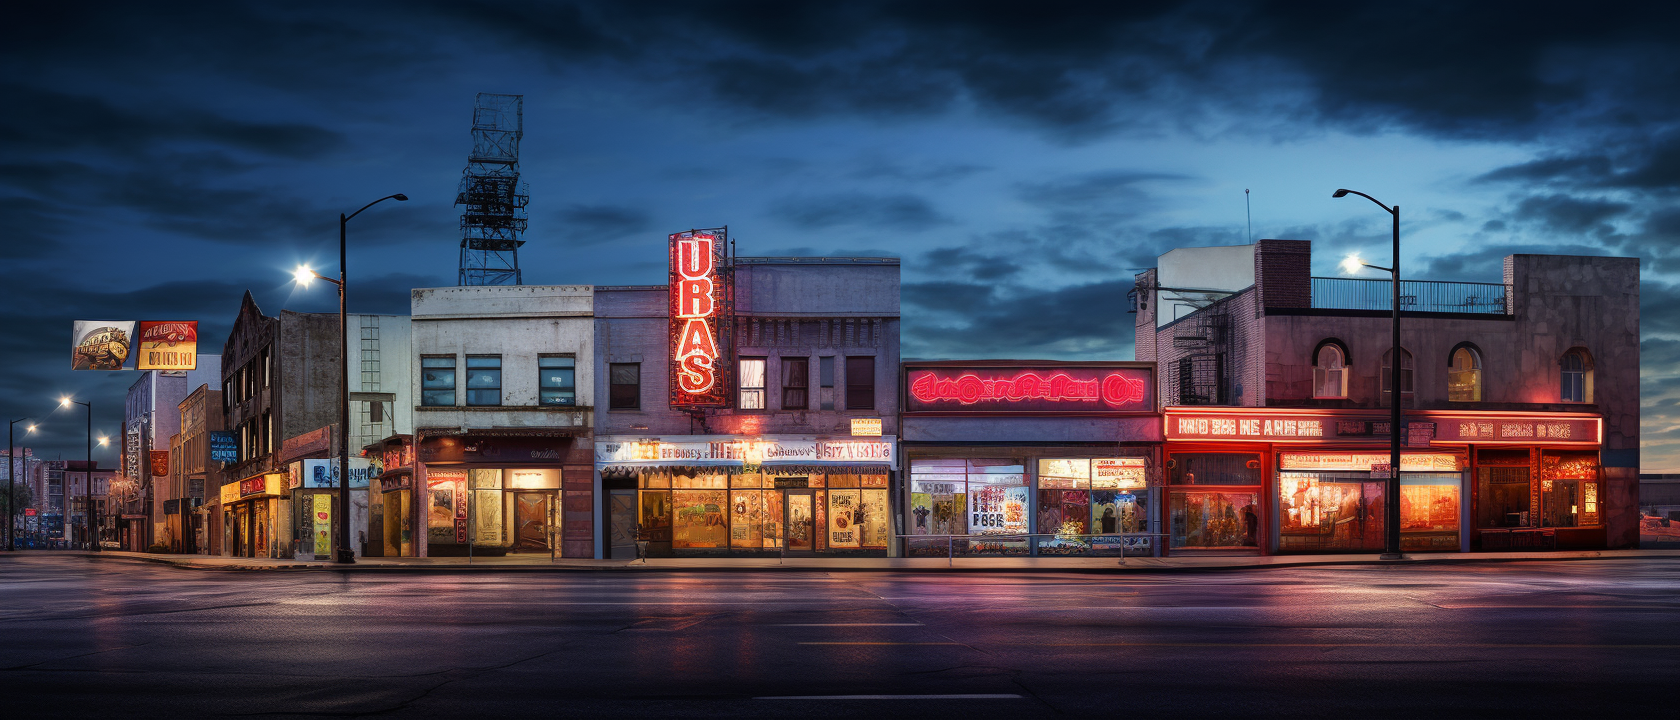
[16,550,1680,572]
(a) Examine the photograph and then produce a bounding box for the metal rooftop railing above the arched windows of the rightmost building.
[1312,277,1514,316]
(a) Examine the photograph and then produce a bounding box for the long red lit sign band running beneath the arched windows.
[1166,408,1603,446]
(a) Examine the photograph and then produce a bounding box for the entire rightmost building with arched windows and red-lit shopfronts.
[1136,240,1640,552]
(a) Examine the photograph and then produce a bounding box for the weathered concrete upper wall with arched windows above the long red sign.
[1136,240,1640,547]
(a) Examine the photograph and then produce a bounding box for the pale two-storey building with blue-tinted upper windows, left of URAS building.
[408,285,595,557]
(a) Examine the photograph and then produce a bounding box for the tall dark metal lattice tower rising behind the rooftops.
[455,92,529,285]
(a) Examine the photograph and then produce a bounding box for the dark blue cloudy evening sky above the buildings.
[0,0,1680,472]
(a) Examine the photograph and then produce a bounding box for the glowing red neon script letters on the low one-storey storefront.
[911,373,1146,406]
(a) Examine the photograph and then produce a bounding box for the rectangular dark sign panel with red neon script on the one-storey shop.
[906,366,1154,413]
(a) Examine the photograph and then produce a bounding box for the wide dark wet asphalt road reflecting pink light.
[0,554,1680,720]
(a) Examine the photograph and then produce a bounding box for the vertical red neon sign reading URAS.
[669,230,734,408]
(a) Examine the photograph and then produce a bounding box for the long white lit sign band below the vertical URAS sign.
[595,435,895,465]
